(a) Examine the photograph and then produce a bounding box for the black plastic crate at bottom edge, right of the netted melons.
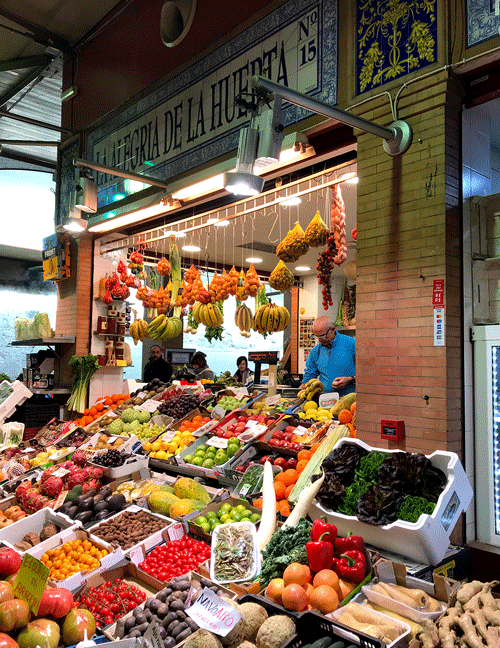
[283,612,385,648]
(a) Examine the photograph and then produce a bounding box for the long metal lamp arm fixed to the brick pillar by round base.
[252,76,412,155]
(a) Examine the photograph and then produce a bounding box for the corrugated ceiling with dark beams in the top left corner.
[0,0,133,171]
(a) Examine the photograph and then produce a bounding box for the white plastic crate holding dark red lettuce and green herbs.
[309,438,473,565]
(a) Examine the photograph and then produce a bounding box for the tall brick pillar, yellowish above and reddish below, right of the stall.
[355,72,462,453]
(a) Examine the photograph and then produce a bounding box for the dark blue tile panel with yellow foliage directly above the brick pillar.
[356,0,437,94]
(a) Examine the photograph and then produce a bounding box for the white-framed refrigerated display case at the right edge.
[472,324,500,547]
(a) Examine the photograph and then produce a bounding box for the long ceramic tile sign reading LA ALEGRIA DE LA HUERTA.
[86,0,338,220]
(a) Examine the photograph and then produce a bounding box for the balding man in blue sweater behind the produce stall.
[300,315,356,396]
